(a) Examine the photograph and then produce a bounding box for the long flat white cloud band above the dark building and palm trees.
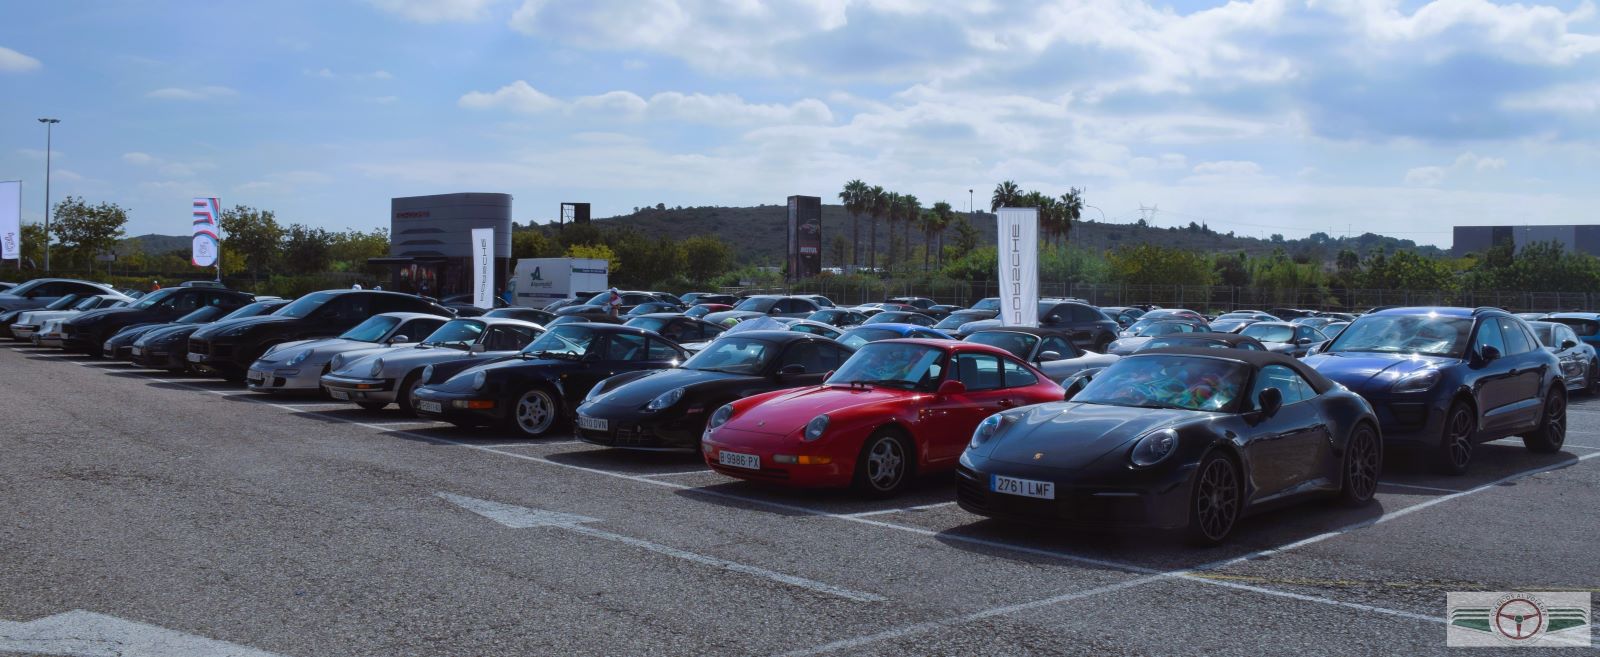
[456,80,834,125]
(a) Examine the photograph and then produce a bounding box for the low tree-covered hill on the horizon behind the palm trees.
[595,205,1445,267]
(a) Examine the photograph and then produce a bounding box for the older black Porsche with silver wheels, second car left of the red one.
[414,321,688,438]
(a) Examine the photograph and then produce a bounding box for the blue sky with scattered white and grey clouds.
[0,0,1600,246]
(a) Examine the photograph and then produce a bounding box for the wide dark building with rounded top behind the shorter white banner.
[368,193,510,297]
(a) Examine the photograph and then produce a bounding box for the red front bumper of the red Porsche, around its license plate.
[701,428,861,488]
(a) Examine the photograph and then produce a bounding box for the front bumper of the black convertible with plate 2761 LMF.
[955,464,1194,529]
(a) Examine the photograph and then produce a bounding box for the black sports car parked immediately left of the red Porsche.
[576,331,854,449]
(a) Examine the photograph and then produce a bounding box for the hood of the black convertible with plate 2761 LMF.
[976,401,1216,470]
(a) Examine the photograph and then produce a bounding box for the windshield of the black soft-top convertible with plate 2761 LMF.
[1072,353,1250,411]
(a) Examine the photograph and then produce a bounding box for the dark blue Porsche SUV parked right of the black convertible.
[1306,307,1566,475]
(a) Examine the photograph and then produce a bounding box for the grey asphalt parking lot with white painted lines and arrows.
[0,347,1600,655]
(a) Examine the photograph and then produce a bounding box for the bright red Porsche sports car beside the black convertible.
[702,339,1064,497]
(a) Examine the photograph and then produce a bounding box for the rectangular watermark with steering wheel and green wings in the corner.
[1445,591,1592,647]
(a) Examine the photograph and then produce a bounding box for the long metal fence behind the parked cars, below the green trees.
[726,278,1600,312]
